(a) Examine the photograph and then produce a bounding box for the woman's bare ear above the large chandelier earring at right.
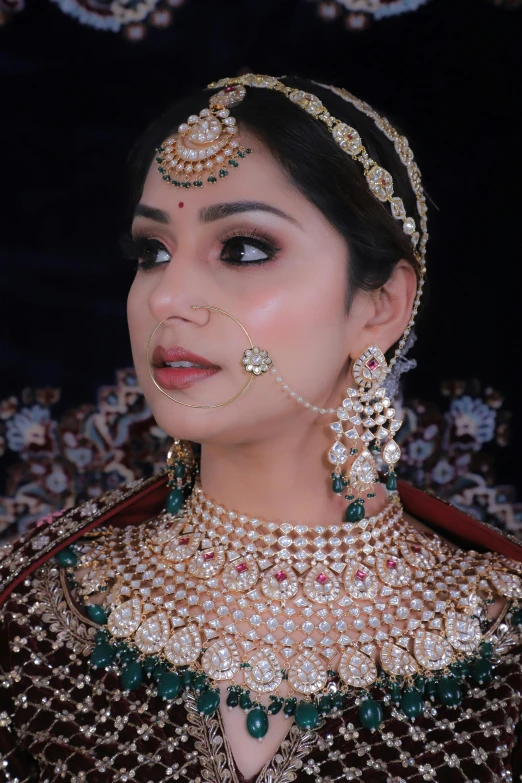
[352,259,417,358]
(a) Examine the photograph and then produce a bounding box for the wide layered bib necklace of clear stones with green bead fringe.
[59,478,522,739]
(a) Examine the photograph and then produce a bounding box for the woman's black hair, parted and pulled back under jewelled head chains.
[126,77,420,352]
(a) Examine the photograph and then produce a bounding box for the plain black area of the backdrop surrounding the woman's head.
[0,0,522,486]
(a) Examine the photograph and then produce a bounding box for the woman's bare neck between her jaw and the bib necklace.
[197,427,387,527]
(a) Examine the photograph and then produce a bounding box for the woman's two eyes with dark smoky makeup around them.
[120,230,280,270]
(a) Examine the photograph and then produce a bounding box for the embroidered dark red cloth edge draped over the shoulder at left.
[0,473,168,606]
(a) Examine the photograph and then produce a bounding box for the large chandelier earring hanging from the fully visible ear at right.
[328,345,402,522]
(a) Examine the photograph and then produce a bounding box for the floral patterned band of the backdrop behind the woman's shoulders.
[0,369,522,539]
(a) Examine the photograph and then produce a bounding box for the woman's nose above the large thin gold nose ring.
[148,253,210,326]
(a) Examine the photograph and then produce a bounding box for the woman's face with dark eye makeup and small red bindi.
[128,137,378,444]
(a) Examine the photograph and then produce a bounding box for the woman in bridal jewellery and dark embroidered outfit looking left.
[0,75,522,783]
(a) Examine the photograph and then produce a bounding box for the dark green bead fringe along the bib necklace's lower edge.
[71,550,522,740]
